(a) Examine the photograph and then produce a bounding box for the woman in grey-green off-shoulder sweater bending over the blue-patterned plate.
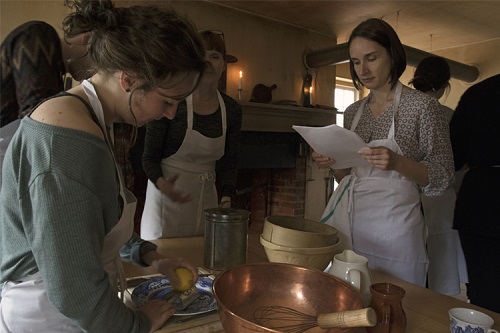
[0,0,205,333]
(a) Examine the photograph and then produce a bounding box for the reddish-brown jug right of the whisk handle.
[366,282,406,333]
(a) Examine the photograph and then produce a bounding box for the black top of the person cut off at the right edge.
[450,75,500,239]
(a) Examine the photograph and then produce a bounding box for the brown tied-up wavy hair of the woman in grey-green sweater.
[63,0,205,91]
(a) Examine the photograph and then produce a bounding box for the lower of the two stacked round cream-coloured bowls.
[260,235,341,271]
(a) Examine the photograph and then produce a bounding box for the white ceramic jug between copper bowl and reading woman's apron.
[328,250,372,306]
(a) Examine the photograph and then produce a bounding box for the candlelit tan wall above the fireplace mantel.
[159,1,336,106]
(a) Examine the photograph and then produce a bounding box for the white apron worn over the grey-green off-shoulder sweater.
[0,80,136,333]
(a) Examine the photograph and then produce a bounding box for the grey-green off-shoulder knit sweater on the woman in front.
[0,117,150,333]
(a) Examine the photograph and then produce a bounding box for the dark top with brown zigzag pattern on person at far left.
[0,21,65,127]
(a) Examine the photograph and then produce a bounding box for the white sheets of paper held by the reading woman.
[292,124,369,169]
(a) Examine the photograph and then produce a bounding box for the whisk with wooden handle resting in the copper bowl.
[253,305,377,333]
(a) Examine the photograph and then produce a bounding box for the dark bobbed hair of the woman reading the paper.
[347,18,406,90]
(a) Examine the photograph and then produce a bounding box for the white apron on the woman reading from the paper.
[324,82,427,286]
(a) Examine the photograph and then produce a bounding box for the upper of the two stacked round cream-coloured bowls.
[262,216,338,248]
